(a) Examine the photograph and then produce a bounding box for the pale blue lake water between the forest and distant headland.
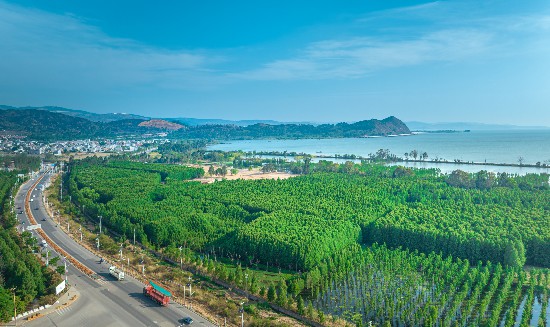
[209,130,550,174]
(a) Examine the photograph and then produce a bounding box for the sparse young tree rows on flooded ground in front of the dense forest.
[144,240,550,326]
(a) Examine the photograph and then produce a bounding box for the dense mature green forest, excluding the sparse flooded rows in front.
[70,161,550,270]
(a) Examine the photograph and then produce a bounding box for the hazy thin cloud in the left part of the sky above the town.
[0,1,220,90]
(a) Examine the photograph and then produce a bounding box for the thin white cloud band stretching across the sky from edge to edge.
[0,0,550,102]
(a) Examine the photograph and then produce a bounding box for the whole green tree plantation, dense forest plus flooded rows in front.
[66,159,550,326]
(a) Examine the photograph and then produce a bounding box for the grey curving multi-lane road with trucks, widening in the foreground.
[15,174,215,327]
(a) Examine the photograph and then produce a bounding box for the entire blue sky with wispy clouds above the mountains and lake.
[0,0,550,126]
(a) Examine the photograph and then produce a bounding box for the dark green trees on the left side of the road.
[0,172,61,321]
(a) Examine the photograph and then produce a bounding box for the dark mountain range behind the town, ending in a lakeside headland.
[0,106,410,140]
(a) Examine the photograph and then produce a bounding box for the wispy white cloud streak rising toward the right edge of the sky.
[233,1,550,80]
